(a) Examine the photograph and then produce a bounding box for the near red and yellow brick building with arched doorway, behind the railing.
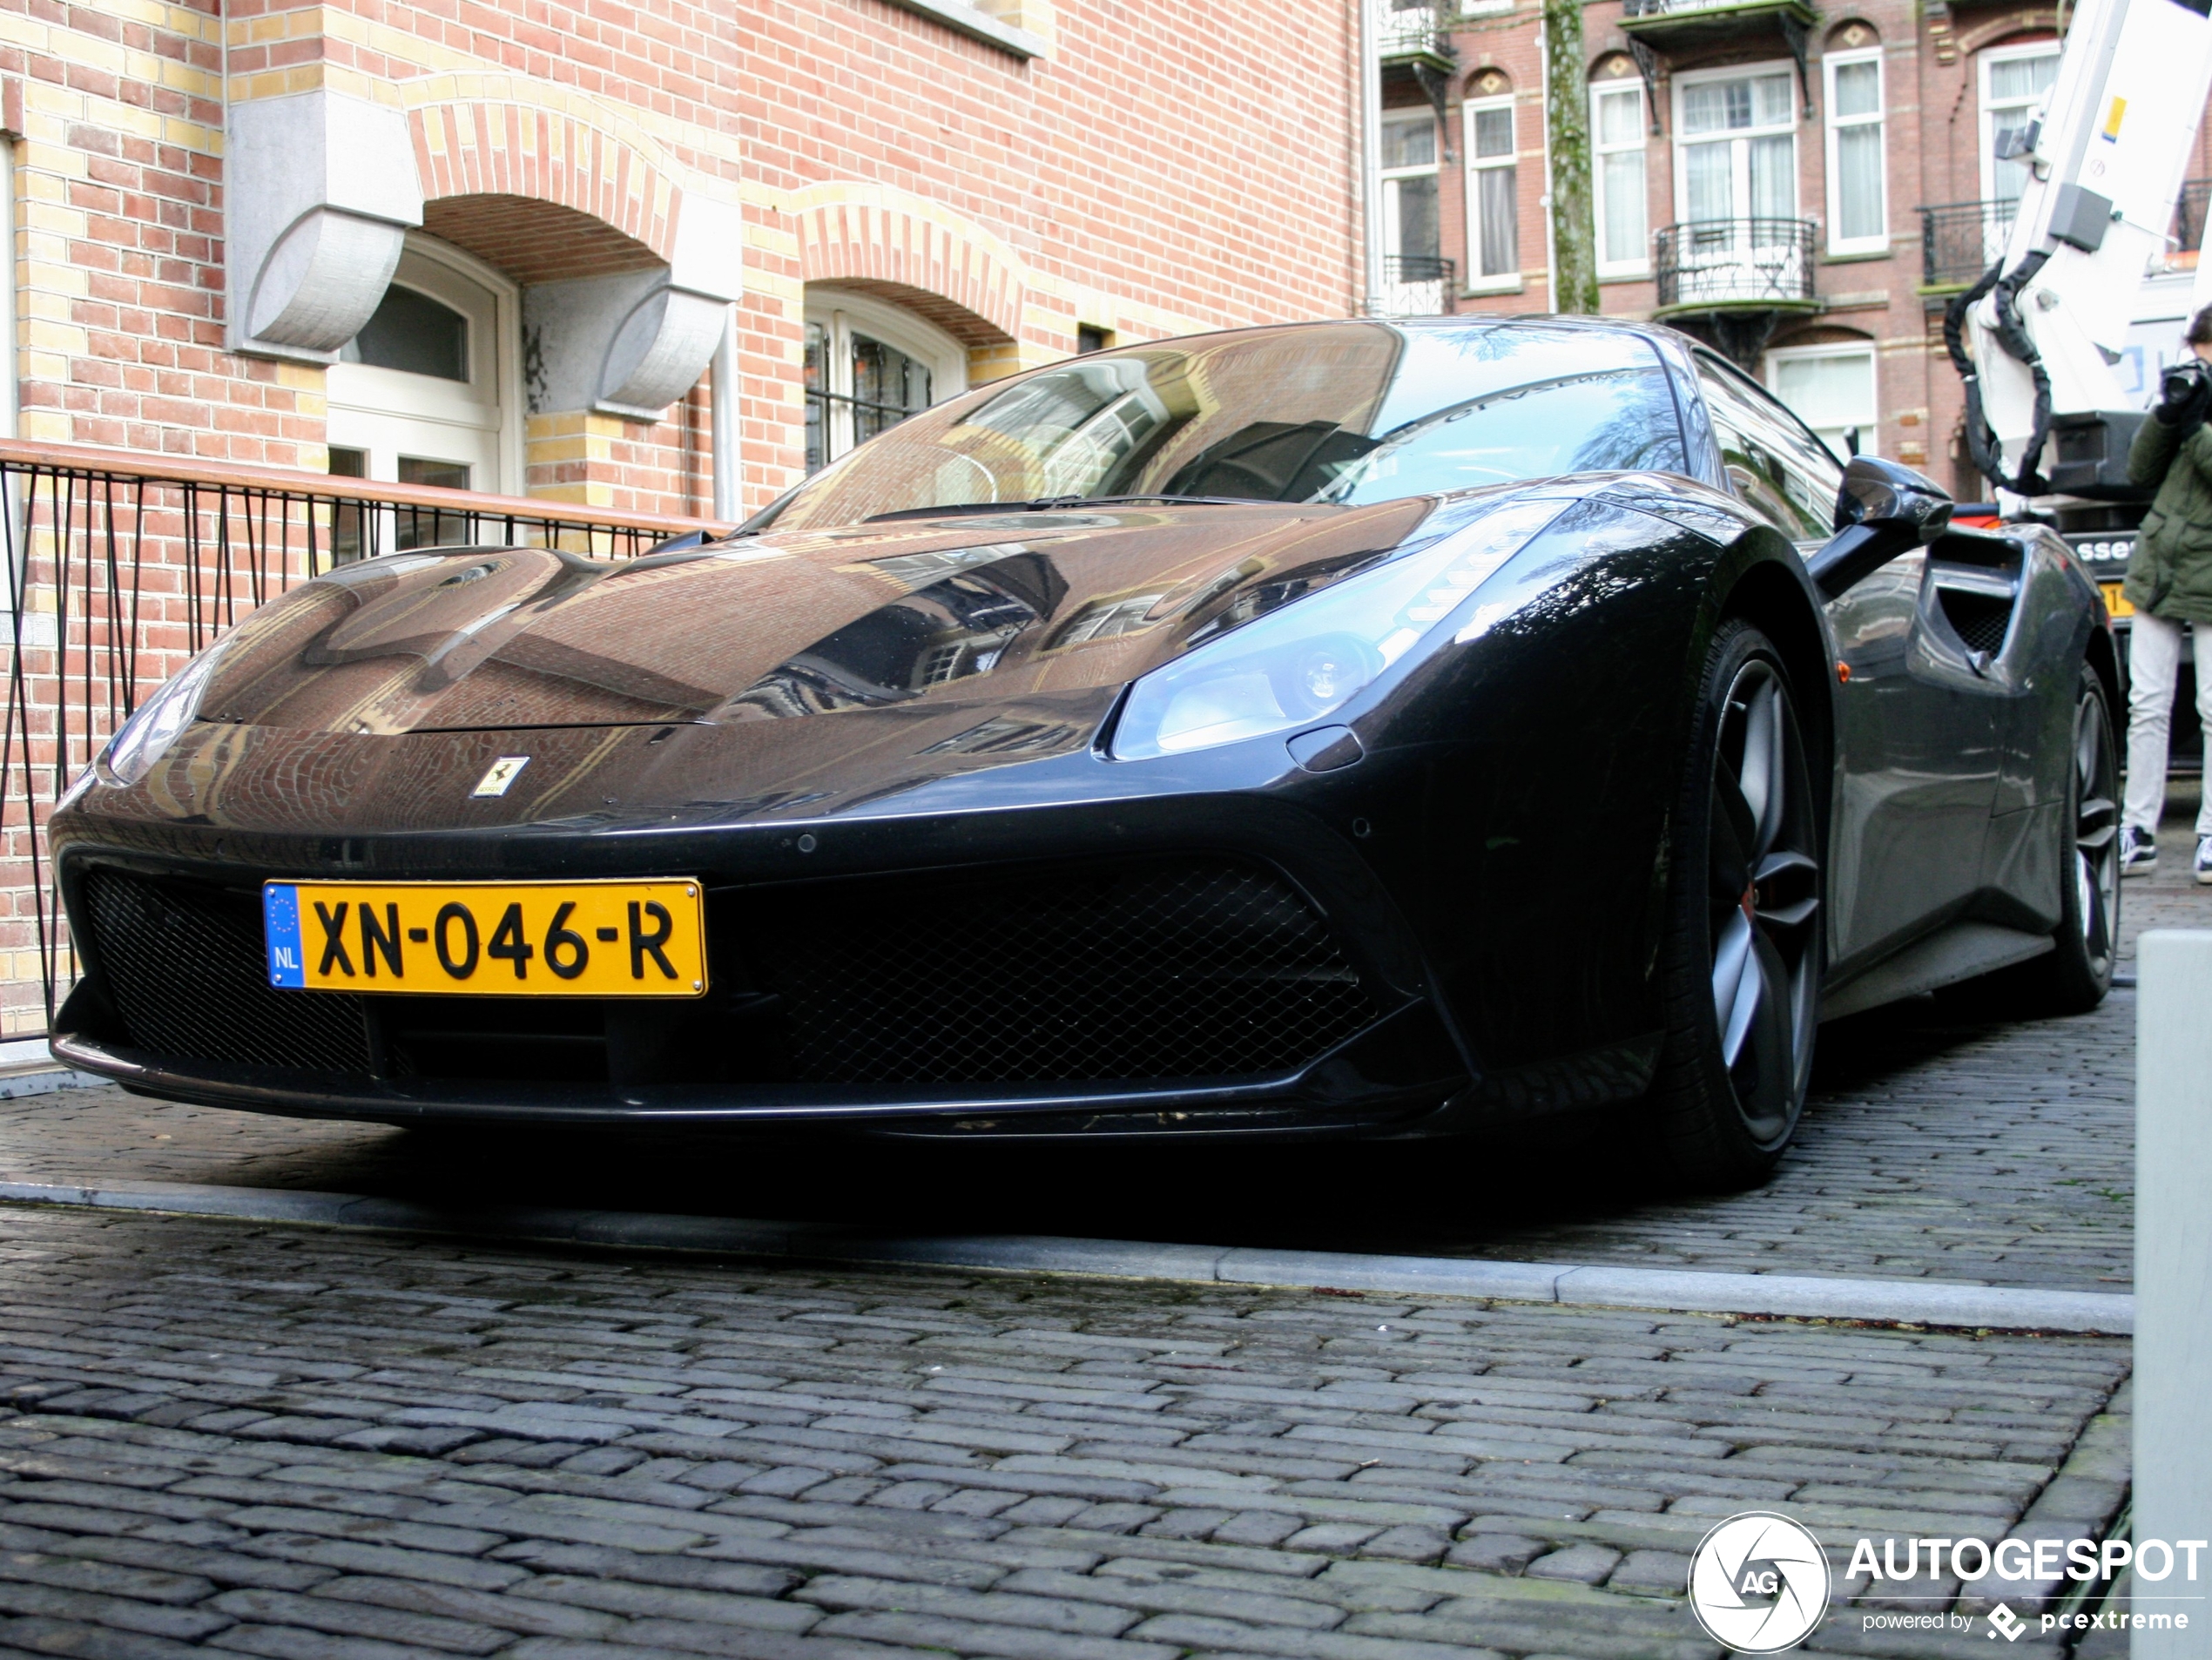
[0,0,1359,514]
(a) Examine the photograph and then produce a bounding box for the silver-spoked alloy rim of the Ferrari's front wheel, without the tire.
[1708,658,1820,1149]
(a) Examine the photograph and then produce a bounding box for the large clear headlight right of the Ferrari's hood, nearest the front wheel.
[1113,500,1566,761]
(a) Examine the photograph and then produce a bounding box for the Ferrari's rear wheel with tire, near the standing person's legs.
[1988,664,2119,1014]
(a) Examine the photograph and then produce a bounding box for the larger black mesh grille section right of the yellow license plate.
[754,859,1376,1084]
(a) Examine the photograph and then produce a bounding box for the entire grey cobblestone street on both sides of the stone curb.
[0,787,2212,1660]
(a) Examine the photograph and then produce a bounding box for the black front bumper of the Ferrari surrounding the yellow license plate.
[43,734,1474,1136]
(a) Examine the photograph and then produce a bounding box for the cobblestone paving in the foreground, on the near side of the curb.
[0,1211,2126,1660]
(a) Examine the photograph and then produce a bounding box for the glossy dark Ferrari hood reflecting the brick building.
[199,498,1438,735]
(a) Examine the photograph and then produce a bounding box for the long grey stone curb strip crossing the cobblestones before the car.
[0,1180,2134,1337]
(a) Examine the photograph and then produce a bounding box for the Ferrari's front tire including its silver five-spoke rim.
[1648,617,1825,1191]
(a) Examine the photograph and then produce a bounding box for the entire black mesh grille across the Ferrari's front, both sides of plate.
[69,859,1376,1087]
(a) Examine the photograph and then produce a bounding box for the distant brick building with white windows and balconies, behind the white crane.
[1380,0,2212,498]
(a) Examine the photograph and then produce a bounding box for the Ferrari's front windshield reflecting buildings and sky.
[752,321,1683,529]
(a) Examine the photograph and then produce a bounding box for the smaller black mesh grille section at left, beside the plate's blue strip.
[84,870,369,1071]
